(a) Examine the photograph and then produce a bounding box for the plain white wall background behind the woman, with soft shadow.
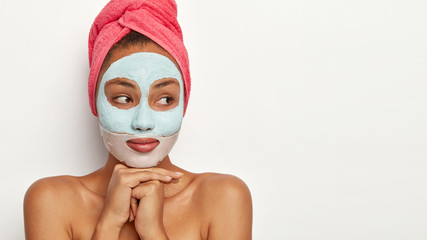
[0,0,427,240]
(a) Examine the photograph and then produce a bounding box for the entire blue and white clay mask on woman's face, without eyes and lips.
[96,52,184,168]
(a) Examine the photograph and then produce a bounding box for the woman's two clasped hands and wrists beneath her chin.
[92,164,182,239]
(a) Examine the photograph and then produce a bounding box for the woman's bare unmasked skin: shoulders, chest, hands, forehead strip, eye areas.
[24,43,252,240]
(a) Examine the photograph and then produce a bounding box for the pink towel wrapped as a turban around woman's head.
[89,0,191,116]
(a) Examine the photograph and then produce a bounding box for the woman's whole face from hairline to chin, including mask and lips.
[96,43,184,167]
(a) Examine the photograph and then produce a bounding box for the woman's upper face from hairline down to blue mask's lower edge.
[97,43,183,136]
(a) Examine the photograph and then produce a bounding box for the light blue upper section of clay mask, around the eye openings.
[97,52,184,136]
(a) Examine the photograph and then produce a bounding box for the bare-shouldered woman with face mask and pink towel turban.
[24,0,252,240]
